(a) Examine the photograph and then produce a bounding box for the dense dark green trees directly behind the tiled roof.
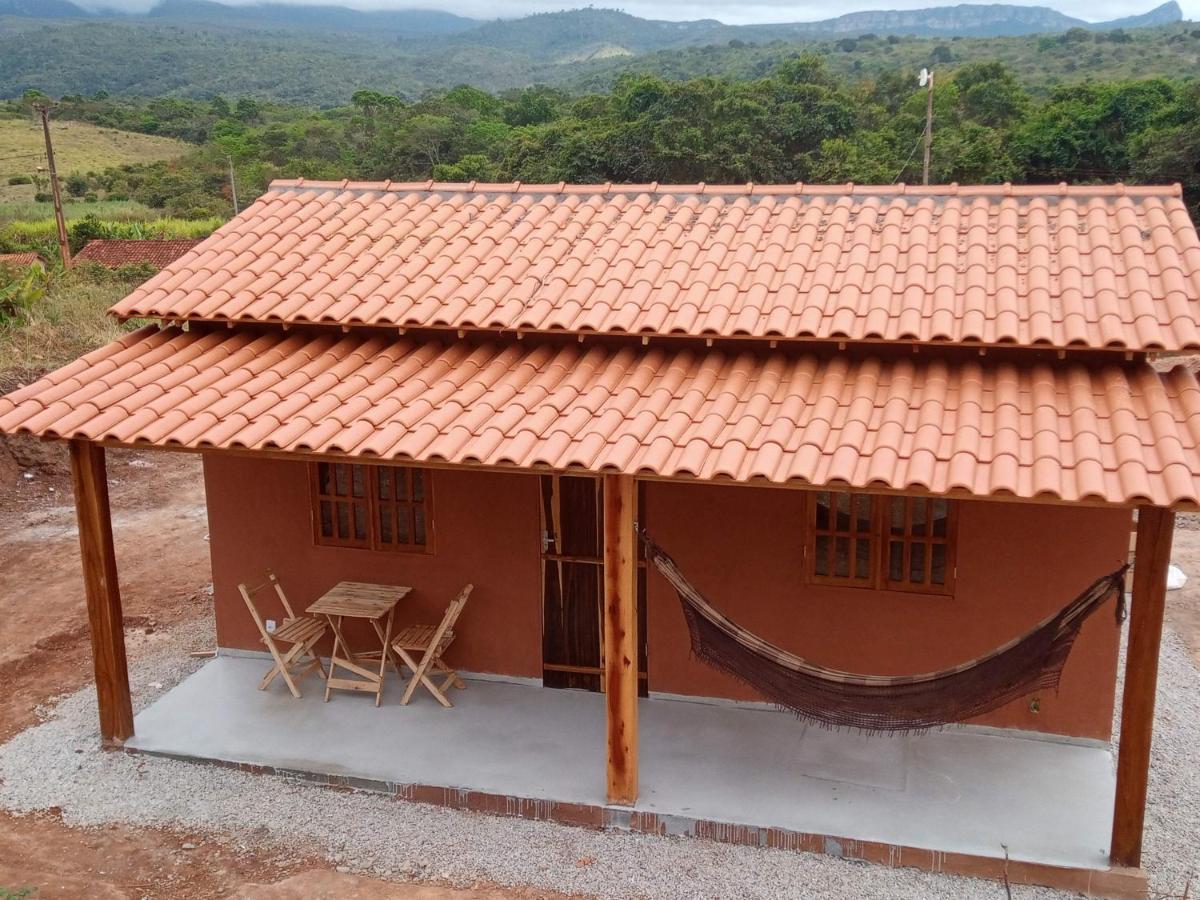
[7,54,1200,237]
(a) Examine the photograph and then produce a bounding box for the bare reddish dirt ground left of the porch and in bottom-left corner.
[0,436,547,900]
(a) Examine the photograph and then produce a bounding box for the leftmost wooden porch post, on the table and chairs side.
[71,440,133,745]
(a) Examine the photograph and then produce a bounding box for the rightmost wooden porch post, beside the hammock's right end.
[1109,506,1175,869]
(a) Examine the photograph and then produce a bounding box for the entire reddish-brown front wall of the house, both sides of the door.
[204,455,1129,738]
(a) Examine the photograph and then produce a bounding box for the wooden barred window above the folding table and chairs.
[312,462,430,550]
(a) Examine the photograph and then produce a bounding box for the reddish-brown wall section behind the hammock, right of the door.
[644,482,1130,738]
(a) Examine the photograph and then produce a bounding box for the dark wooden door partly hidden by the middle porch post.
[541,475,647,696]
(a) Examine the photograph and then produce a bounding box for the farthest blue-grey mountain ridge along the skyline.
[0,0,1183,41]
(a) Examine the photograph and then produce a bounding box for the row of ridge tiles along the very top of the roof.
[269,178,1183,197]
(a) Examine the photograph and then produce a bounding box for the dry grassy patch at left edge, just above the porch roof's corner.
[0,271,143,376]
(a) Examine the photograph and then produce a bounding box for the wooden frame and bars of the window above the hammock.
[803,490,959,596]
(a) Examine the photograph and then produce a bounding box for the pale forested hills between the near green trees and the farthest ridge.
[0,8,1200,107]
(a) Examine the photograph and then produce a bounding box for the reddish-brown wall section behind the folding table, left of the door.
[204,455,541,678]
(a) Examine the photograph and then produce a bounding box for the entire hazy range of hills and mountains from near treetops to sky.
[0,0,1200,106]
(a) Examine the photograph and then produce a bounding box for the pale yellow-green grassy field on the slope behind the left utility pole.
[0,116,191,204]
